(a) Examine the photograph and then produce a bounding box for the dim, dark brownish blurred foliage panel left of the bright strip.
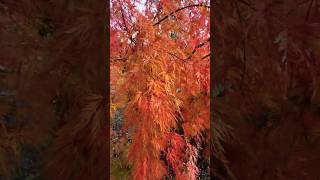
[0,0,109,180]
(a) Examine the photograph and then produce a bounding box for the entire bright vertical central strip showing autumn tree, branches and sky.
[110,0,210,180]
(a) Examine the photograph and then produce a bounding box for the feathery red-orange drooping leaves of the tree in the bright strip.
[113,0,210,180]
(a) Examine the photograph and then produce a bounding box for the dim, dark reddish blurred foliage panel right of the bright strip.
[213,0,320,180]
